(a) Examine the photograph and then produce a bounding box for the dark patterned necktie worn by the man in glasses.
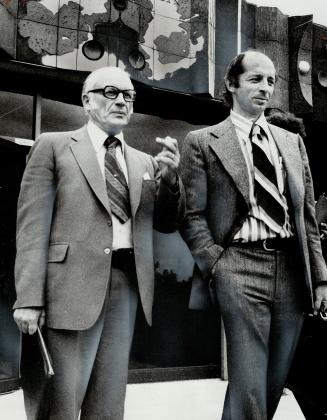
[104,136,131,223]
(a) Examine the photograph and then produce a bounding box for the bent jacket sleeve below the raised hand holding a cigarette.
[152,158,185,233]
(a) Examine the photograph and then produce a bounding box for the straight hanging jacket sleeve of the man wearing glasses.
[14,135,55,309]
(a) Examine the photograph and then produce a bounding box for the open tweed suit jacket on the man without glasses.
[181,117,327,308]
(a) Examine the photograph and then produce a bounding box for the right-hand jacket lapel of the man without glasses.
[269,124,304,204]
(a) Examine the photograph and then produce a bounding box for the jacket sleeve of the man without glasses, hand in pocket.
[181,133,223,278]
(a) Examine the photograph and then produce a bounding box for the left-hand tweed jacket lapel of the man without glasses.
[209,118,250,205]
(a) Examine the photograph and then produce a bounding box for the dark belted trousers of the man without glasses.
[213,245,305,420]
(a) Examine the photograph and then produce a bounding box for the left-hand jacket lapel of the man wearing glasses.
[70,126,110,214]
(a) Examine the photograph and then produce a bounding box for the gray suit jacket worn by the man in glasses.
[14,127,185,330]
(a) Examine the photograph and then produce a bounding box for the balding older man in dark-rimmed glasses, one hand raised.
[14,67,185,420]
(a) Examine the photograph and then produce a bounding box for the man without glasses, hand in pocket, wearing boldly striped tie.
[181,51,327,420]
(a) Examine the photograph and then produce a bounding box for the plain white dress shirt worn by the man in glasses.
[87,120,133,249]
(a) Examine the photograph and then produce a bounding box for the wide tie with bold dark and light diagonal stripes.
[250,124,285,233]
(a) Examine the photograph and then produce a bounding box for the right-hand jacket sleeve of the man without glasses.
[298,136,327,286]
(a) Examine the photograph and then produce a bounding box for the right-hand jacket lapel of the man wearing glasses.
[125,144,146,217]
